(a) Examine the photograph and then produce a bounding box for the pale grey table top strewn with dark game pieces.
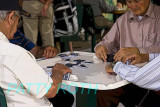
[37,51,129,90]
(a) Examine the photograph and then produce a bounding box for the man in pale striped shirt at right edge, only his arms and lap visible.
[106,53,160,107]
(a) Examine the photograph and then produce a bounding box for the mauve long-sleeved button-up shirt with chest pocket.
[95,2,160,54]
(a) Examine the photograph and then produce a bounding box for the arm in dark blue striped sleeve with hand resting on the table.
[9,30,57,58]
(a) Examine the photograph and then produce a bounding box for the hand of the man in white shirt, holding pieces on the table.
[53,63,72,75]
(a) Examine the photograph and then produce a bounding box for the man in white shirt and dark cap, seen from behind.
[0,0,74,107]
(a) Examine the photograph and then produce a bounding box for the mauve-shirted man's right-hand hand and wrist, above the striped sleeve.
[114,47,139,62]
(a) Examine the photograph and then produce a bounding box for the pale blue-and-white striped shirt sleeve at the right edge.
[113,54,160,91]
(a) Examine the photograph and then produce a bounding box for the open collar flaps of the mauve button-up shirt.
[129,2,155,21]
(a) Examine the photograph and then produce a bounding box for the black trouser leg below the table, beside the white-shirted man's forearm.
[49,89,74,107]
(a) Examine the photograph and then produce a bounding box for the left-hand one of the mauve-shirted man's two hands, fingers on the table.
[95,45,107,62]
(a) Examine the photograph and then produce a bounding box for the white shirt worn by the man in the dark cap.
[0,32,53,107]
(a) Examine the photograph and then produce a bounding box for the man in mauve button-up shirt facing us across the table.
[95,0,160,107]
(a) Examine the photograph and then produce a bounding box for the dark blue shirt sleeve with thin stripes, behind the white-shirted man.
[10,30,36,51]
